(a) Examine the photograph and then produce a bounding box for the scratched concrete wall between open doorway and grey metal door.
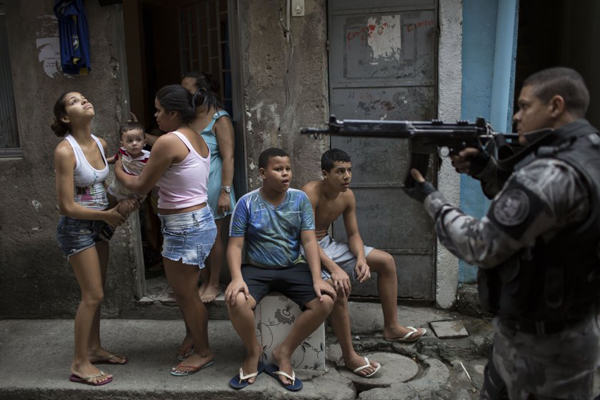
[239,0,329,190]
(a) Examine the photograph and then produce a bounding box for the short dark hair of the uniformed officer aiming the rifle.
[523,67,590,118]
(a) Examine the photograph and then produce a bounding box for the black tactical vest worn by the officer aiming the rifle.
[478,120,600,321]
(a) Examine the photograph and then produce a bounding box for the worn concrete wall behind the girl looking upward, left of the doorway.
[0,0,140,318]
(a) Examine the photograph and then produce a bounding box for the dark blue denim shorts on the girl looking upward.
[56,215,106,261]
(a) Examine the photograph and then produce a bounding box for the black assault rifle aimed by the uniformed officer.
[300,115,518,188]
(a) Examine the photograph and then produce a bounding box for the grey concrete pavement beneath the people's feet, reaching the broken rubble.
[0,304,489,400]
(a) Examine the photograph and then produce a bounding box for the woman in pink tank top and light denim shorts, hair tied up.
[115,85,217,376]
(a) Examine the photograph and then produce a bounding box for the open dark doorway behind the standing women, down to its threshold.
[123,0,247,303]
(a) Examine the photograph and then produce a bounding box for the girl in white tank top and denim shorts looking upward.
[52,92,135,386]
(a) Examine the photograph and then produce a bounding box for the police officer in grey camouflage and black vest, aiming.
[407,68,600,400]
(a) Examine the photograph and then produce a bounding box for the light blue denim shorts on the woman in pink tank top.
[158,206,217,269]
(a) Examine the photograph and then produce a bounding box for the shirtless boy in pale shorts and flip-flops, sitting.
[302,149,426,377]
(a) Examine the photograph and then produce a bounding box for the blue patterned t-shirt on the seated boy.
[229,189,315,268]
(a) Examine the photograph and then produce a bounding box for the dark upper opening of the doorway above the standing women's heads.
[123,0,233,134]
